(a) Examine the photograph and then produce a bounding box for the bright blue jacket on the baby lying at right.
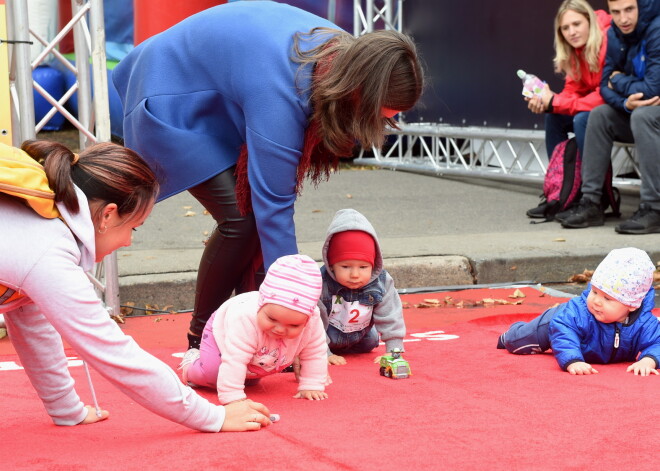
[549,285,660,370]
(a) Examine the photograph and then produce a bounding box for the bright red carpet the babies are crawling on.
[0,288,660,471]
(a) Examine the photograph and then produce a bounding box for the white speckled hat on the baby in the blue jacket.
[591,247,655,308]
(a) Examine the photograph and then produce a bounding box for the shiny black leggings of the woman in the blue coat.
[189,167,264,336]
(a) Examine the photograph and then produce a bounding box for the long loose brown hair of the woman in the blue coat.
[294,27,424,156]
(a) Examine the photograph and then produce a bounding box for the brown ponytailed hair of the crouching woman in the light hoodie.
[21,140,158,220]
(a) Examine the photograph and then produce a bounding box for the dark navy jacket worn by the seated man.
[600,0,660,112]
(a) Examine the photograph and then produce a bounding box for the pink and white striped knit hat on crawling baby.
[258,255,322,316]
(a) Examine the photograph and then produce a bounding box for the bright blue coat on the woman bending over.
[112,1,338,267]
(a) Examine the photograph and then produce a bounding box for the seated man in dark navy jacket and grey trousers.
[556,0,660,234]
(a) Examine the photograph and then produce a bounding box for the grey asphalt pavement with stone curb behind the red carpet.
[117,167,660,310]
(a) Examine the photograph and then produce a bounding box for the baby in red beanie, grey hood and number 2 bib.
[320,209,406,365]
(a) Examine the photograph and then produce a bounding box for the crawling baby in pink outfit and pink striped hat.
[180,255,329,404]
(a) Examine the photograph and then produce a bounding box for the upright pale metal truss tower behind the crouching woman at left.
[2,0,119,315]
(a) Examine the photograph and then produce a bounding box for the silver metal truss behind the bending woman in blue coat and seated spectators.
[353,0,640,191]
